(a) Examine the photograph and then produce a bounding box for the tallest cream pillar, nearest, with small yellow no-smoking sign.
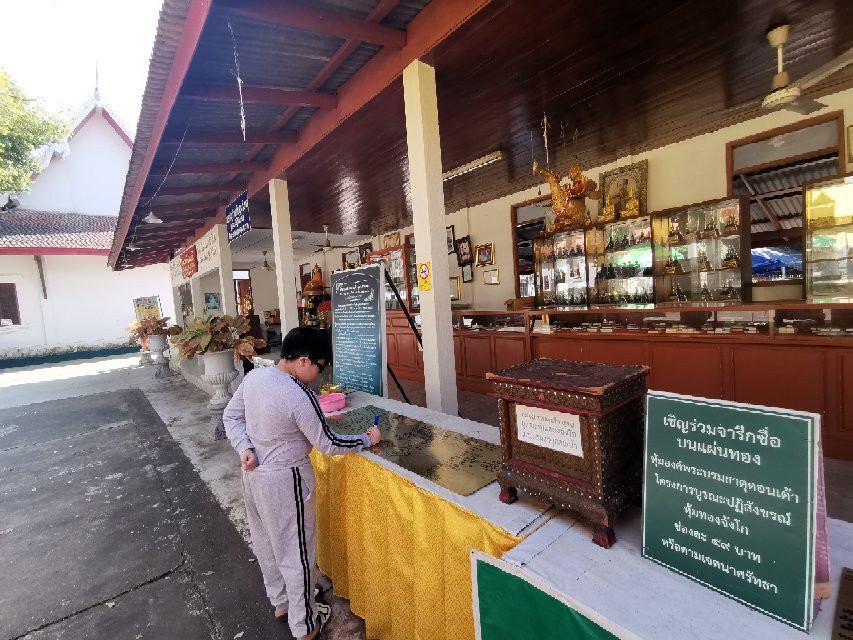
[403,60,458,415]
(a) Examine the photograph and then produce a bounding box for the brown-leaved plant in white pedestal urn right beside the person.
[172,316,267,438]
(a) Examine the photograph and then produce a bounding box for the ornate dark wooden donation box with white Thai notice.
[486,358,649,548]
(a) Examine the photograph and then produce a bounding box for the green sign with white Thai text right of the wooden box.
[643,391,820,631]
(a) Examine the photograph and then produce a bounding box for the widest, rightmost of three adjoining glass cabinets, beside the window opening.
[652,198,752,306]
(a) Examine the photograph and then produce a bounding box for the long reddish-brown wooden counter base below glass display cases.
[380,314,853,460]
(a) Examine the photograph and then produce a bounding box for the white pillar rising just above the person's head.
[270,180,299,335]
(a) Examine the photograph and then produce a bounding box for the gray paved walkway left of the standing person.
[0,357,364,640]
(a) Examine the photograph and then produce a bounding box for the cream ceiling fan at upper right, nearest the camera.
[761,24,853,115]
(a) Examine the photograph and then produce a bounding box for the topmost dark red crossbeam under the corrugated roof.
[217,0,406,50]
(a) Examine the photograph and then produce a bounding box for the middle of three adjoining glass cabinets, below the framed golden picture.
[586,217,654,309]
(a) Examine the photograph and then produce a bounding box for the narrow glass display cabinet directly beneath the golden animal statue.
[533,229,587,309]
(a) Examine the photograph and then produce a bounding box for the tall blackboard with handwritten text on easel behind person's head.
[332,264,387,396]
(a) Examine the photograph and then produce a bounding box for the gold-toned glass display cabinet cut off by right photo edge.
[804,175,853,303]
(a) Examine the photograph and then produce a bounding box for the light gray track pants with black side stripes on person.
[243,463,318,638]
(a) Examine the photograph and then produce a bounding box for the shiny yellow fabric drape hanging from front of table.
[311,451,523,640]
